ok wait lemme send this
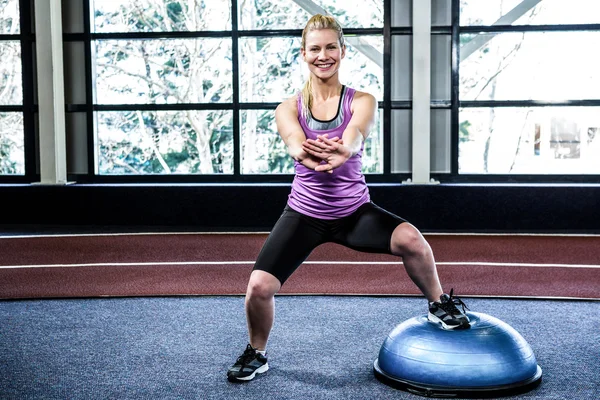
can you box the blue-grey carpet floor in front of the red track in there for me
[0,296,600,400]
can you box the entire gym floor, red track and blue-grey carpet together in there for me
[0,232,600,399]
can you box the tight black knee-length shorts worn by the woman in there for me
[254,203,406,285]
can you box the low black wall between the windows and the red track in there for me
[0,184,600,233]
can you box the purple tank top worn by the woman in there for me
[288,86,370,219]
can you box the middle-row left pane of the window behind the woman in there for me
[94,38,233,104]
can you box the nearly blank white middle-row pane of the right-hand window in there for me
[460,31,600,101]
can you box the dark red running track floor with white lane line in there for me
[0,233,600,299]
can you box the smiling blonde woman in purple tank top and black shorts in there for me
[227,15,469,381]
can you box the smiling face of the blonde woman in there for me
[302,29,346,80]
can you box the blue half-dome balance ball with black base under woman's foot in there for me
[373,312,542,398]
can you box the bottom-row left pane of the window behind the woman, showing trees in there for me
[96,110,233,175]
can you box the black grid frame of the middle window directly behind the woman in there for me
[70,0,391,184]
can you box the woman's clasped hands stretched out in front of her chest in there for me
[300,134,351,174]
